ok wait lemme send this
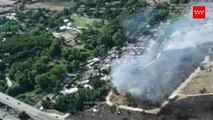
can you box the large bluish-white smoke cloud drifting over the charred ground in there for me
[111,3,213,102]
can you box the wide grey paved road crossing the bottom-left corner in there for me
[0,92,59,120]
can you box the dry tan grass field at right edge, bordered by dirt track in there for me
[181,70,213,94]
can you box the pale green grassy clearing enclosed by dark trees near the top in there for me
[71,15,100,27]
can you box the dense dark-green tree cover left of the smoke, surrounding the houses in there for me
[0,0,172,113]
